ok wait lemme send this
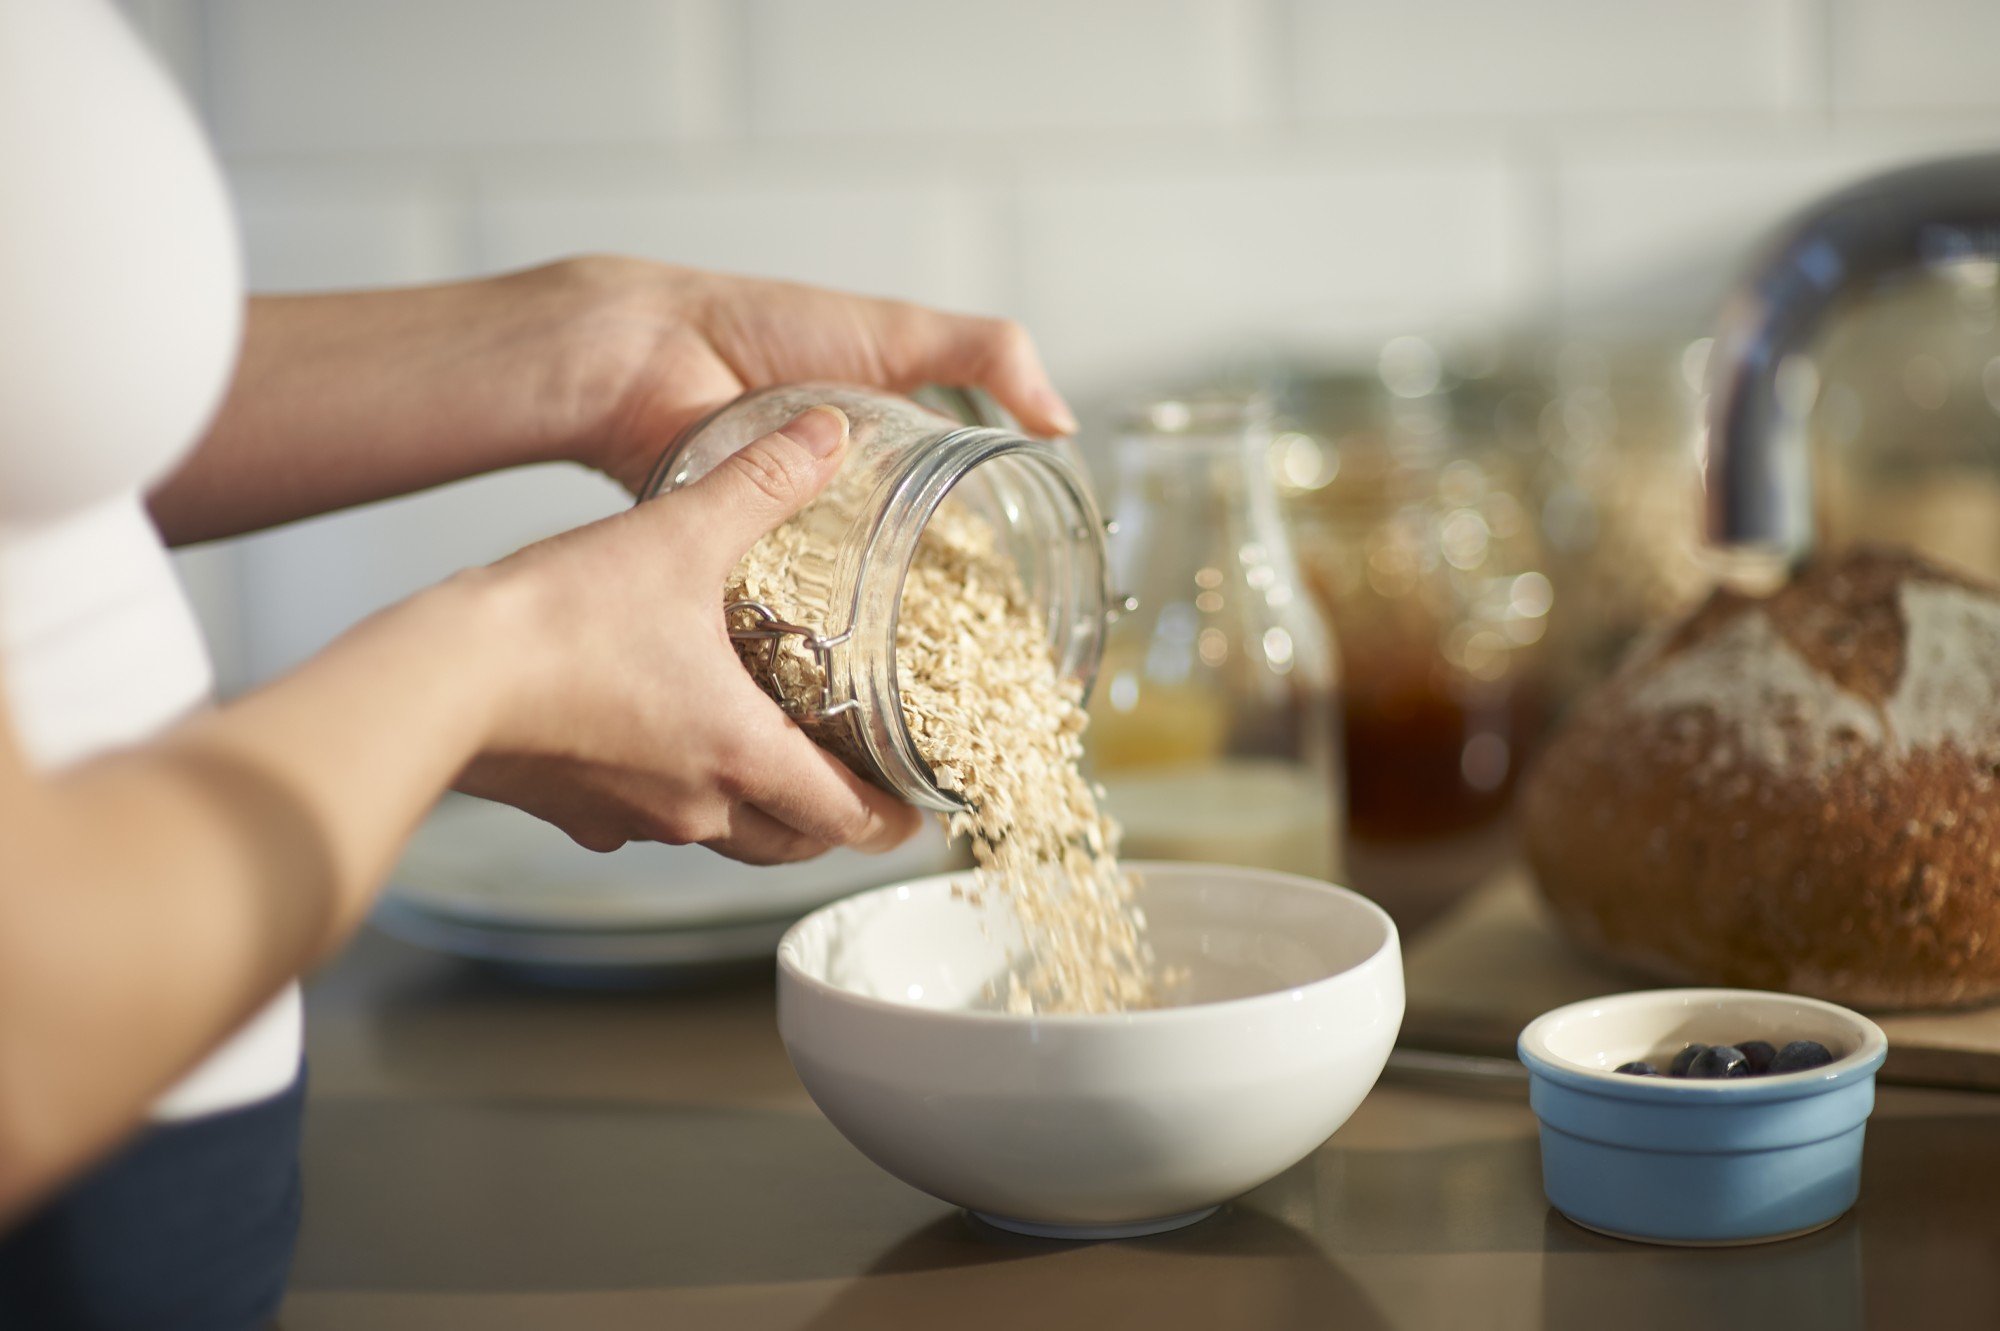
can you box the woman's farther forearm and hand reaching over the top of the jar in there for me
[152,258,1076,546]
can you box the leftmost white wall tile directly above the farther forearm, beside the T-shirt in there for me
[230,164,466,292]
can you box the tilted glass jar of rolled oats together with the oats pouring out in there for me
[644,384,1158,1011]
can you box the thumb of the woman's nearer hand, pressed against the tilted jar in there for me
[668,406,848,572]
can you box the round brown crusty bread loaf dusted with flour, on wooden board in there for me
[1522,550,2000,1009]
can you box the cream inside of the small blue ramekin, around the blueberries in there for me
[1522,989,1882,1073]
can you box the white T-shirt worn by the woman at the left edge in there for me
[0,0,300,1119]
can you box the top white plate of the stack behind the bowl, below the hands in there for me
[384,795,964,927]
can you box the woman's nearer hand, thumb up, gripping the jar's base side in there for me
[458,408,920,863]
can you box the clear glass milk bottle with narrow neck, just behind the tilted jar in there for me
[1086,398,1342,877]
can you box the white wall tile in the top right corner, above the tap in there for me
[1832,0,2000,111]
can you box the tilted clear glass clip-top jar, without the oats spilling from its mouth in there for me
[640,384,1110,813]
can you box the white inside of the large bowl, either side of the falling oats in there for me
[778,863,1394,1011]
